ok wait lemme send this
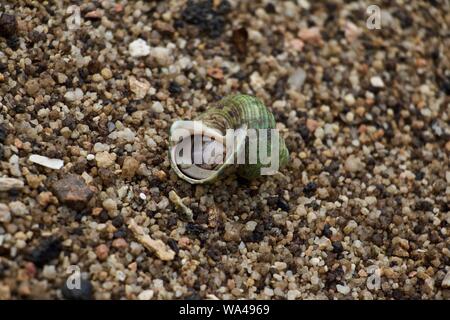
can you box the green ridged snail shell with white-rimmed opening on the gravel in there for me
[169,94,289,184]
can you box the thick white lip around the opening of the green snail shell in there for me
[169,120,247,184]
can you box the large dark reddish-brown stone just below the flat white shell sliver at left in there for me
[52,174,94,210]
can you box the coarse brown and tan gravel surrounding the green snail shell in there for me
[0,0,450,300]
